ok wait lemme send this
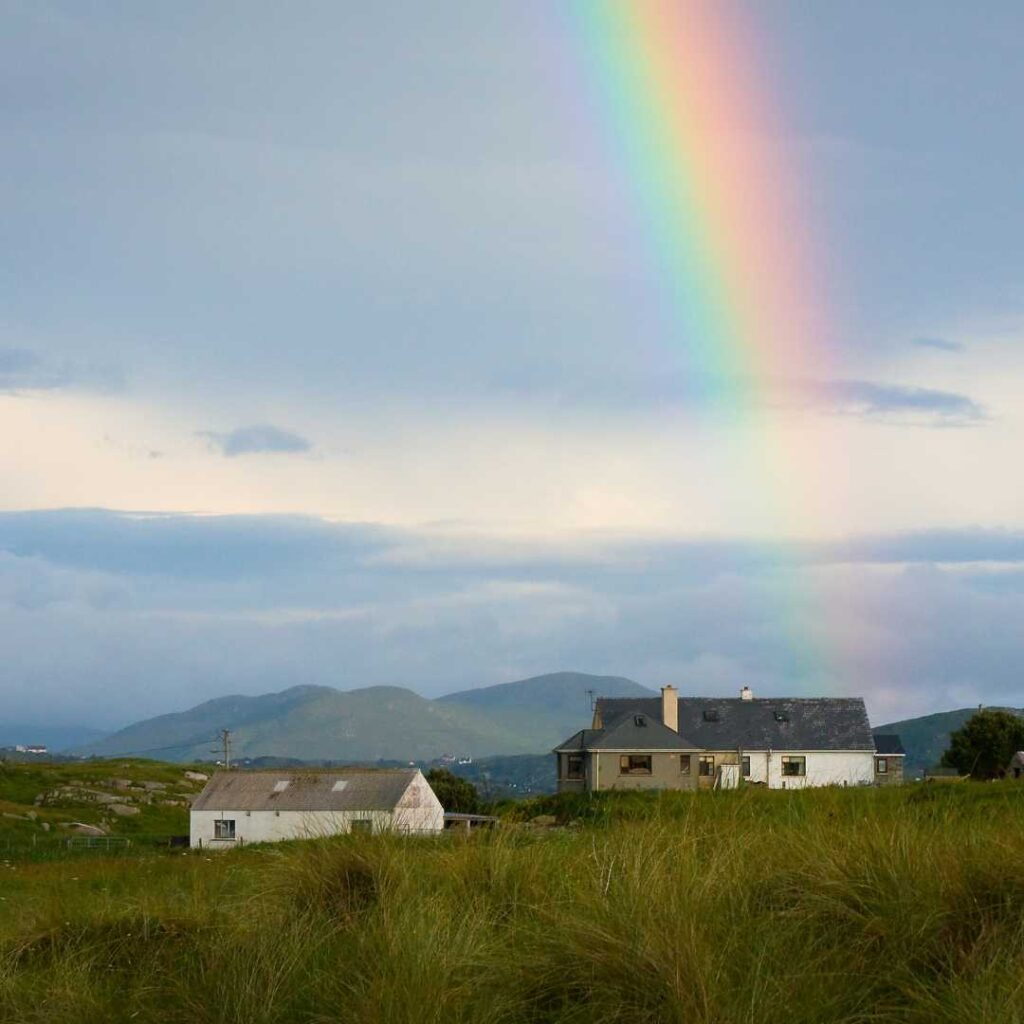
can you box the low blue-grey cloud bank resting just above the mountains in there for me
[0,510,1024,725]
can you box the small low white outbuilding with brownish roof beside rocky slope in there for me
[189,768,444,850]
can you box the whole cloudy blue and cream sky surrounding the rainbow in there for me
[0,0,1024,728]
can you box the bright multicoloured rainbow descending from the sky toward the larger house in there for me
[567,0,837,683]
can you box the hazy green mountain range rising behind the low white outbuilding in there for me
[77,672,651,761]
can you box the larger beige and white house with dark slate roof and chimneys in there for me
[554,686,903,793]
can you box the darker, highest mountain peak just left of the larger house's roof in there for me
[437,672,656,754]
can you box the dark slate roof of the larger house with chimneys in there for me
[559,697,876,751]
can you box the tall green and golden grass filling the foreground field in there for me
[0,783,1024,1024]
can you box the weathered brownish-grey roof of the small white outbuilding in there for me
[191,768,417,811]
